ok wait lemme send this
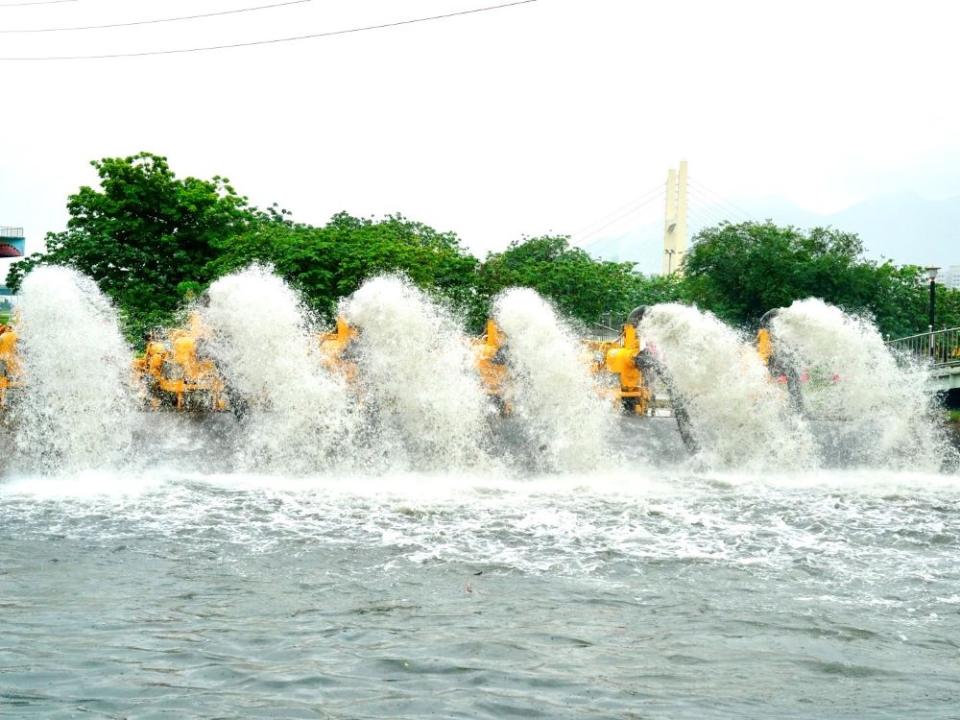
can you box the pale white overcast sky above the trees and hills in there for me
[0,0,960,279]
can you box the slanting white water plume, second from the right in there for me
[640,303,816,469]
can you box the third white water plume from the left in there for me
[341,276,493,469]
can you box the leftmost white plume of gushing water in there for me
[10,266,135,473]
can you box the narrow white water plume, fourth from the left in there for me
[494,288,616,471]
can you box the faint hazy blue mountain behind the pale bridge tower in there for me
[583,193,960,272]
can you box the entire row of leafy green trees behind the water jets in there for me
[7,153,960,338]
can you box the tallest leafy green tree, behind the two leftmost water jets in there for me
[7,153,256,336]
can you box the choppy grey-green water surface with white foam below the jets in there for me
[0,467,960,718]
